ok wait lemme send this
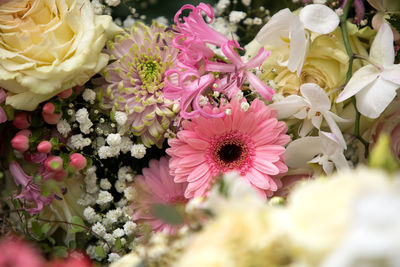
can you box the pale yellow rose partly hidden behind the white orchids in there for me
[246,23,374,100]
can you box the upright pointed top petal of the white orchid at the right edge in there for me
[369,23,394,66]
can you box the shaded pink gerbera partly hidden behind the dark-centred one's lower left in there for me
[133,157,187,233]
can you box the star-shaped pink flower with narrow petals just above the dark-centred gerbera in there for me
[204,41,274,101]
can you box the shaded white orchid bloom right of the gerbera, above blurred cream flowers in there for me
[285,131,349,174]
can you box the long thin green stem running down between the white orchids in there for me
[340,0,369,158]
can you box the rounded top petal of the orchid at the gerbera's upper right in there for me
[300,83,331,111]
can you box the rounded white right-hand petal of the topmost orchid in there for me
[299,4,339,34]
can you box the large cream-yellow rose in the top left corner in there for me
[0,0,119,110]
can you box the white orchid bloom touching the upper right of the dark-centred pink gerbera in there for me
[269,83,348,147]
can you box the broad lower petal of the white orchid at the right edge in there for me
[356,77,399,119]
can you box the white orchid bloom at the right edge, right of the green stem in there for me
[336,23,400,119]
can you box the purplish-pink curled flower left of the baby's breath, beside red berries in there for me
[9,162,53,214]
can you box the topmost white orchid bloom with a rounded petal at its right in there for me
[256,4,339,76]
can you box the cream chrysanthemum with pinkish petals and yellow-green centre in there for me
[100,22,178,147]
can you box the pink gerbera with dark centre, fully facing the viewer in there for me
[167,98,290,198]
